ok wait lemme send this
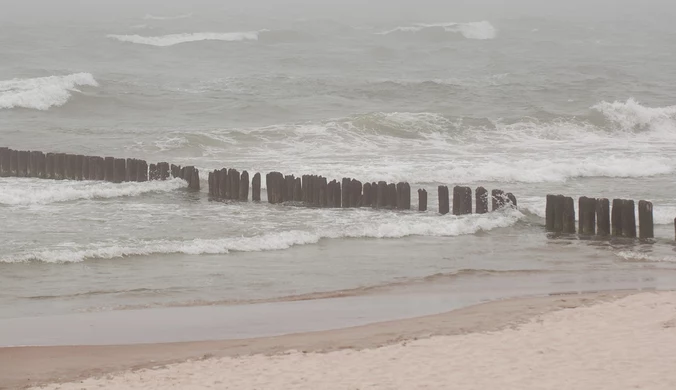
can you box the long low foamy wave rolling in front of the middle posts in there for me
[0,209,523,263]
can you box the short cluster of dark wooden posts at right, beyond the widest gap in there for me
[545,195,654,238]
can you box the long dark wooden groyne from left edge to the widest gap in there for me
[0,147,516,216]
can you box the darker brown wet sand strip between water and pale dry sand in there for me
[0,290,654,389]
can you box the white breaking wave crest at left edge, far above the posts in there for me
[0,73,99,110]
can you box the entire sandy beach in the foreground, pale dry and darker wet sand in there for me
[0,292,676,390]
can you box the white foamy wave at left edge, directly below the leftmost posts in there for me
[0,179,186,206]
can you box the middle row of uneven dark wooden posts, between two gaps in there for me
[209,168,516,215]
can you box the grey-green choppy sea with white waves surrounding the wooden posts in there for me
[0,1,676,345]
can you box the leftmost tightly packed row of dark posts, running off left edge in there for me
[0,147,200,190]
